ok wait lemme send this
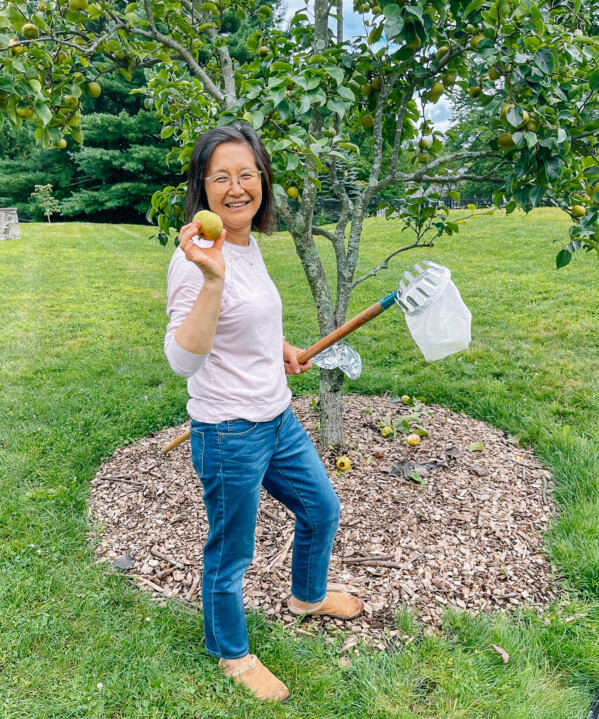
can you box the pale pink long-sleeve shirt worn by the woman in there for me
[164,237,291,423]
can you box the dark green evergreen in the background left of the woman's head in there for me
[0,70,180,222]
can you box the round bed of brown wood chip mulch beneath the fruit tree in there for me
[89,395,560,648]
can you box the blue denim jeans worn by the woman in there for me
[191,408,339,659]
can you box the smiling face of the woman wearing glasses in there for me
[204,142,262,232]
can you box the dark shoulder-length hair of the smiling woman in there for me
[185,122,275,234]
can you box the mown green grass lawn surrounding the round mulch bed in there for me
[0,210,599,719]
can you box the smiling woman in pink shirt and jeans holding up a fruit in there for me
[165,124,363,701]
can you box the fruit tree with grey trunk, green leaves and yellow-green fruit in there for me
[0,0,599,445]
